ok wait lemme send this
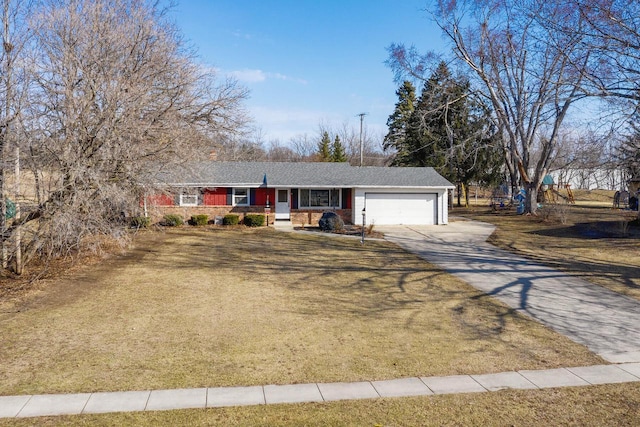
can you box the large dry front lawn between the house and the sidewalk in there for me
[0,228,601,395]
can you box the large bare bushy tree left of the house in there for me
[4,0,246,270]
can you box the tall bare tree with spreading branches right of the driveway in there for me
[390,0,589,213]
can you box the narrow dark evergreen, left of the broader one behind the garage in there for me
[382,80,416,165]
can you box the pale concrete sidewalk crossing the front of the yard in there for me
[0,363,640,418]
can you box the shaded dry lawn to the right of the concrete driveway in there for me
[453,205,640,299]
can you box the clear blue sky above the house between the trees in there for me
[172,0,443,144]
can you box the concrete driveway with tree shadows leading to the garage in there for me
[376,221,640,363]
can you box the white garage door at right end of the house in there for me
[365,193,437,225]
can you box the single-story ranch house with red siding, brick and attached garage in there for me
[144,161,454,225]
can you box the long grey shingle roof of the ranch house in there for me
[158,161,453,188]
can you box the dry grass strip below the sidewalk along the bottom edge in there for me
[0,383,640,427]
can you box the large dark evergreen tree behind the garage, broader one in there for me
[389,63,503,206]
